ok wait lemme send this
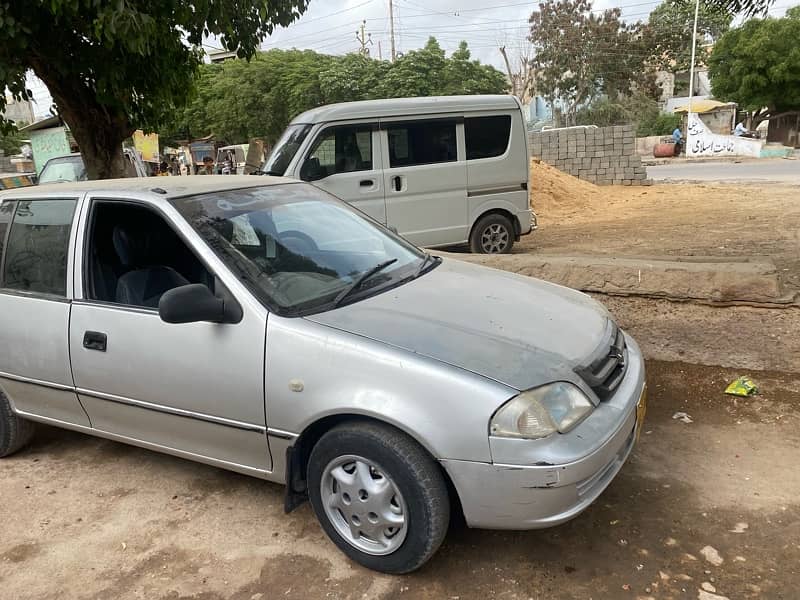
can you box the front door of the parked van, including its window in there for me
[299,123,386,224]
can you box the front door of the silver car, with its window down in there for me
[69,197,272,475]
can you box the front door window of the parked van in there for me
[300,125,372,181]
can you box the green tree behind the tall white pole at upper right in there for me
[643,0,733,72]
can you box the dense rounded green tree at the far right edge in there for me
[709,7,800,127]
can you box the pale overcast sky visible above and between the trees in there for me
[29,0,798,117]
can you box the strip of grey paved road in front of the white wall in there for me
[647,159,800,184]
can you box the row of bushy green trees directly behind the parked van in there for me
[168,38,507,143]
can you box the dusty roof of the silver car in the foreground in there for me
[0,175,298,200]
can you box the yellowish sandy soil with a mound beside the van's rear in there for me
[515,163,800,290]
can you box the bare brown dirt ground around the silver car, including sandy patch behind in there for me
[0,169,800,600]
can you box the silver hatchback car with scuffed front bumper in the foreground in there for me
[0,176,645,573]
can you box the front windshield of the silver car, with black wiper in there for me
[172,183,437,316]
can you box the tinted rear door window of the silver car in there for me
[3,200,78,297]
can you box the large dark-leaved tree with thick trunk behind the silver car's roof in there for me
[0,0,308,179]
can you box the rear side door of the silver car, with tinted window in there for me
[0,194,90,427]
